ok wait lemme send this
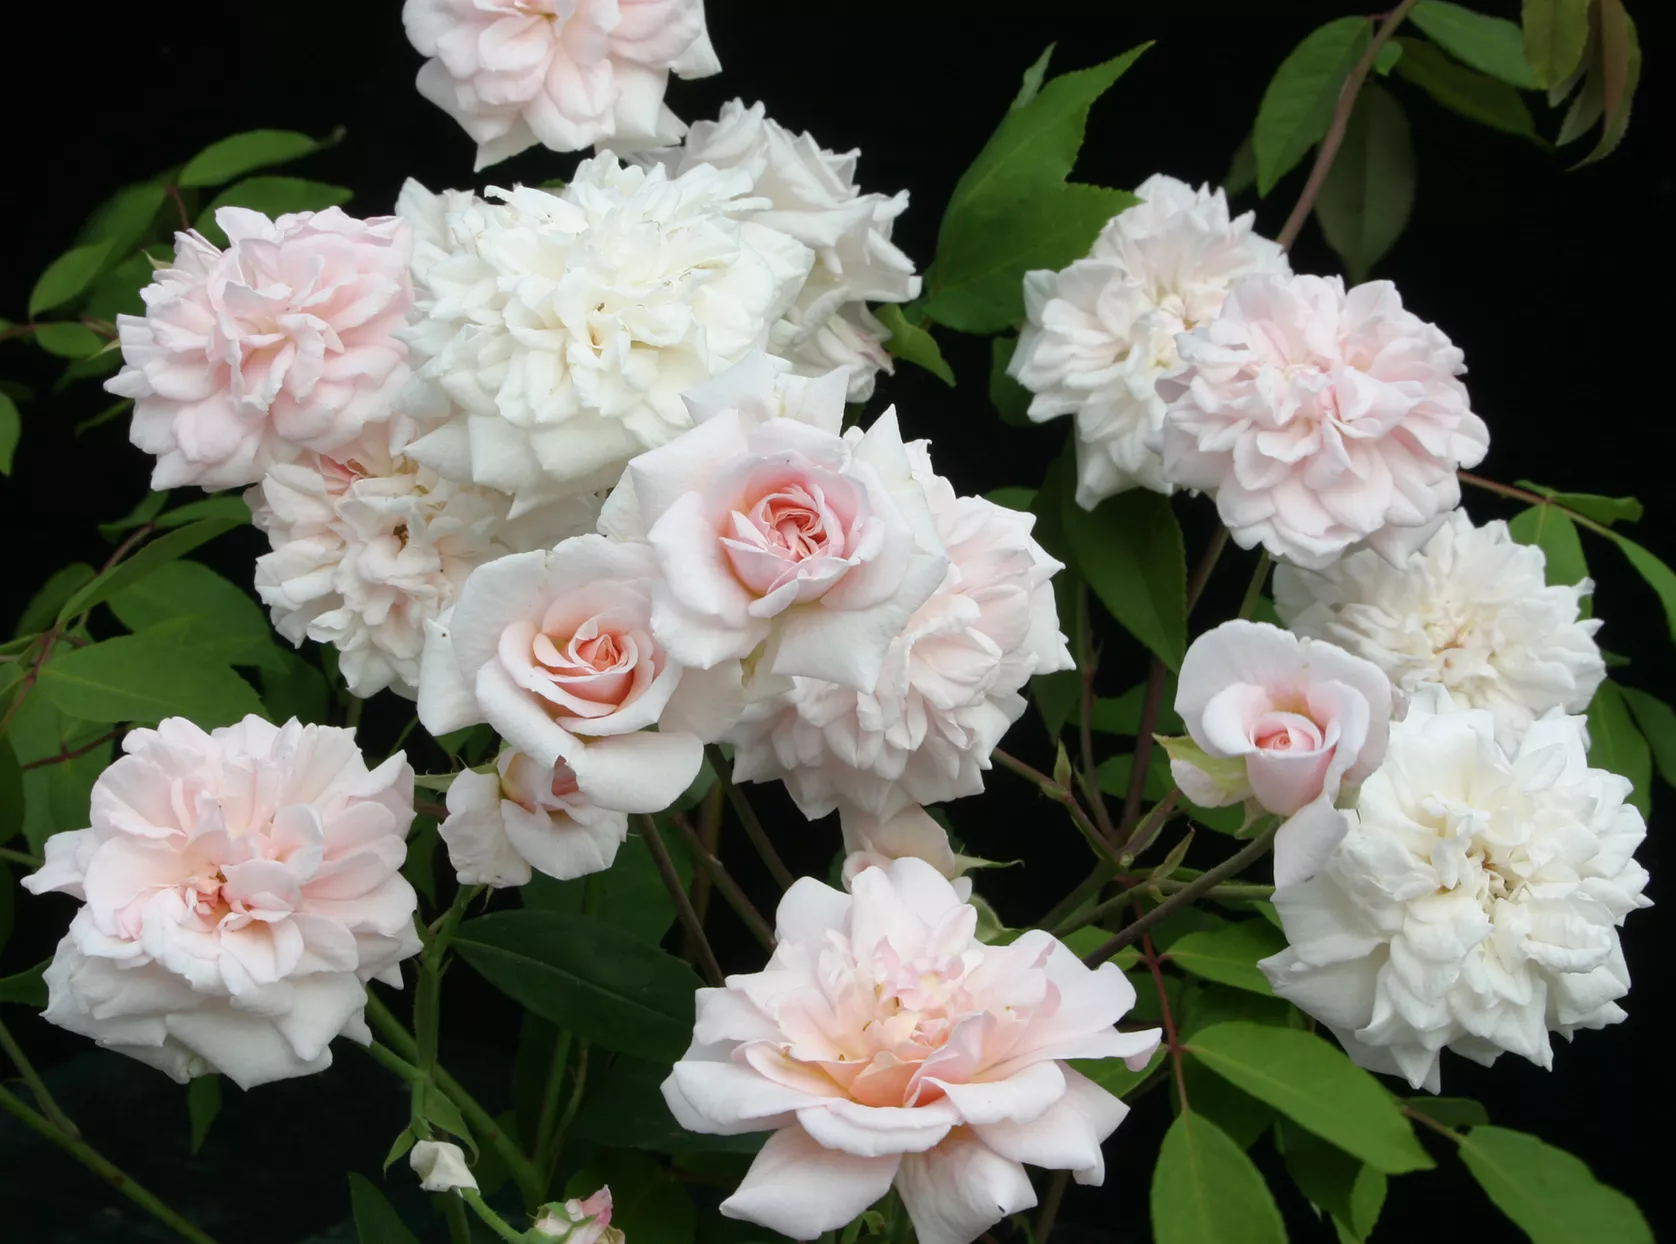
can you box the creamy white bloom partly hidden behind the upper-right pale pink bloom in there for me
[1007,173,1291,510]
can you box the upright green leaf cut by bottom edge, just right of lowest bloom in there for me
[1151,1112,1285,1244]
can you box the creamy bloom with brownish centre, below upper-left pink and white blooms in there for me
[245,416,597,699]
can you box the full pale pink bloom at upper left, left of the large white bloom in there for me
[106,208,412,490]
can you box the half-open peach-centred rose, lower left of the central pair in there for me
[419,535,727,818]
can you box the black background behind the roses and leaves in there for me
[0,0,1676,1244]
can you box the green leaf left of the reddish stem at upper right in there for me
[1252,17,1373,198]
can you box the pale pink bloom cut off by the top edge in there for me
[402,0,721,169]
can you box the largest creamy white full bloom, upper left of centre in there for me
[397,154,815,516]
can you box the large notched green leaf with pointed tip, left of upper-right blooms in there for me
[923,45,1146,332]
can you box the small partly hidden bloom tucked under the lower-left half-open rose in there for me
[439,751,629,887]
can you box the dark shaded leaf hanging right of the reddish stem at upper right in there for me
[1316,82,1414,282]
